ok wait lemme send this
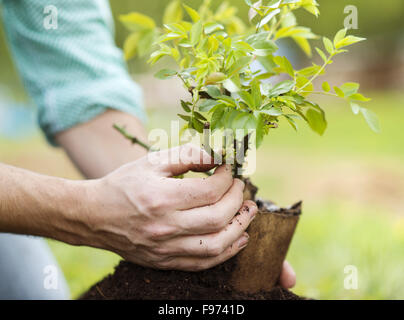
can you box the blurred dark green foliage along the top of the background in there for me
[0,0,404,94]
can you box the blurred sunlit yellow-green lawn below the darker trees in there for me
[0,93,404,299]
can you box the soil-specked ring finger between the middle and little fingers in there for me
[156,201,258,257]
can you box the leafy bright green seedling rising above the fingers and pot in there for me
[120,0,379,176]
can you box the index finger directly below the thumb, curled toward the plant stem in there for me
[161,165,233,210]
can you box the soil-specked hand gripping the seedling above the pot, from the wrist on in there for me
[76,144,257,271]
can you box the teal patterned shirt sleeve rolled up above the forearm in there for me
[2,0,145,144]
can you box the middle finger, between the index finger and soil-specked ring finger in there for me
[170,179,244,235]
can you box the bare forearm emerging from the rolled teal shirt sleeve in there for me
[56,110,147,178]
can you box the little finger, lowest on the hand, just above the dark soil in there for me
[156,235,248,272]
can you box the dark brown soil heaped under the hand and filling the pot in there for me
[80,200,303,300]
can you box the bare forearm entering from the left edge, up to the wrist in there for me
[0,164,91,244]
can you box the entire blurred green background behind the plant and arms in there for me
[0,0,404,299]
